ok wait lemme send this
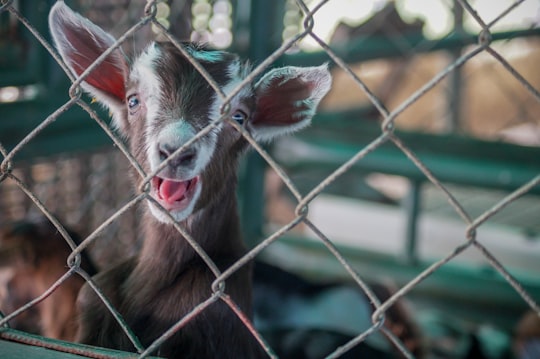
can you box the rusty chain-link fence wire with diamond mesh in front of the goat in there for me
[0,0,540,358]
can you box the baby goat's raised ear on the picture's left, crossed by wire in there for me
[49,1,128,113]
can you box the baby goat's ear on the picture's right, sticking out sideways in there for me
[249,64,332,141]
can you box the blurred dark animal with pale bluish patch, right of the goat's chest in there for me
[254,261,425,359]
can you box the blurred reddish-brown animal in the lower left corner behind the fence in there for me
[0,219,96,341]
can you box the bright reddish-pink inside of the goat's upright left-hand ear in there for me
[66,29,126,101]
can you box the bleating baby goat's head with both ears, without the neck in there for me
[49,2,331,222]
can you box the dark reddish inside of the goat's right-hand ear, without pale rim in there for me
[252,76,314,126]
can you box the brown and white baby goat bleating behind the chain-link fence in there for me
[49,2,331,358]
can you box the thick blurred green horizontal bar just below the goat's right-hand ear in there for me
[276,114,540,194]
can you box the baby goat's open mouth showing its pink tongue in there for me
[152,176,199,211]
